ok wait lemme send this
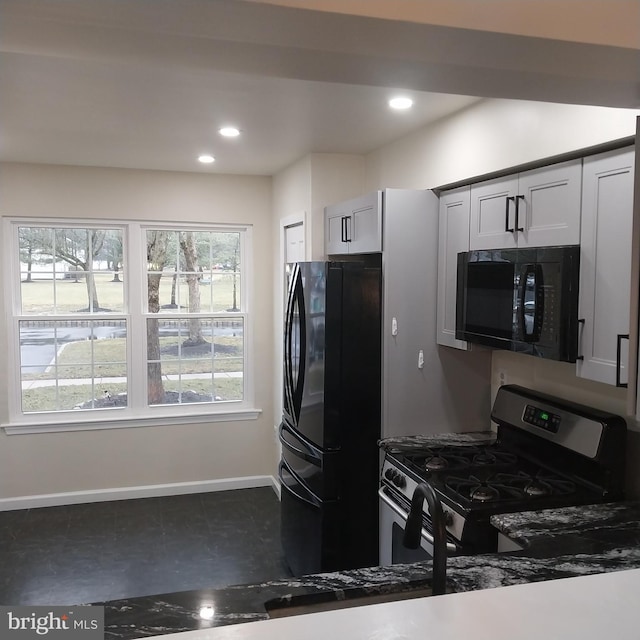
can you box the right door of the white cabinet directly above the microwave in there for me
[515,159,582,247]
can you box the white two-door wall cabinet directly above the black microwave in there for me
[469,160,582,250]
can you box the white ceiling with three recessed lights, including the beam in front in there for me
[0,0,640,175]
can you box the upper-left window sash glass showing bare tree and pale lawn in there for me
[18,227,124,315]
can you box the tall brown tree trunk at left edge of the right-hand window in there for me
[147,231,169,404]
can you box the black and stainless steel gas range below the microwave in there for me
[378,385,626,565]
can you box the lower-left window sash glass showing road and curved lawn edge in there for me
[20,320,127,413]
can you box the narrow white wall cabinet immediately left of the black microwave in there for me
[436,186,471,349]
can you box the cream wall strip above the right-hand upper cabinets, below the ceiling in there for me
[366,100,640,189]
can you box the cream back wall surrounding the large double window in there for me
[0,164,275,499]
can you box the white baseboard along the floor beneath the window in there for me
[0,476,280,511]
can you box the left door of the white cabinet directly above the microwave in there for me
[469,176,518,250]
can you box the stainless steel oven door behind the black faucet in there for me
[378,486,459,567]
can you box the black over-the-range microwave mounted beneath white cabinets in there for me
[456,245,580,362]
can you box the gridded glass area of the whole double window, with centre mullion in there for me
[12,223,247,421]
